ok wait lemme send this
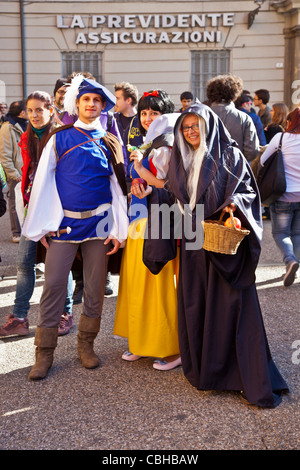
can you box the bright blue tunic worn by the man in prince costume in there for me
[53,127,112,242]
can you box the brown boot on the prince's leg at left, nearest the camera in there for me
[29,326,58,380]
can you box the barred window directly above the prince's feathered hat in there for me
[62,51,102,83]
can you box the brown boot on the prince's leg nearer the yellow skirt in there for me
[77,315,100,369]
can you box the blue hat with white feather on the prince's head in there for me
[64,74,116,115]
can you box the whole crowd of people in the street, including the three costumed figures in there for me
[0,72,294,408]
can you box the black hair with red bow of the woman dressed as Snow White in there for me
[137,90,175,135]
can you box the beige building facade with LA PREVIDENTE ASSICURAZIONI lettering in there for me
[0,0,300,108]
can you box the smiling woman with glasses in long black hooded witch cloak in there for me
[132,103,288,408]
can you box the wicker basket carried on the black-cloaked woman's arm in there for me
[202,209,250,255]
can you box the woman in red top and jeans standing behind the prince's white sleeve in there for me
[0,91,73,336]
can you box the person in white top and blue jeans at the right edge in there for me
[260,108,300,287]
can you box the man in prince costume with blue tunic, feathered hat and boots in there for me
[23,74,128,380]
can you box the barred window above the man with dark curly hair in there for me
[192,50,230,101]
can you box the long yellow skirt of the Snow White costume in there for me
[114,219,179,358]
